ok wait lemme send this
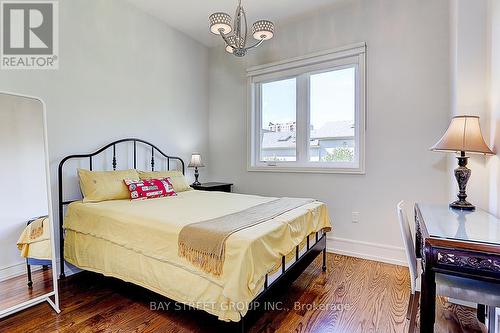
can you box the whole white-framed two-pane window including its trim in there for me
[248,43,365,173]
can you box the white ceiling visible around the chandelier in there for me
[128,0,340,46]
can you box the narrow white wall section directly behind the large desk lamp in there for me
[452,0,490,209]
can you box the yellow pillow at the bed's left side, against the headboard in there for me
[78,169,139,202]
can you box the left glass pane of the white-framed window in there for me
[260,78,297,161]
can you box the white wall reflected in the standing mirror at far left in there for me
[0,94,48,280]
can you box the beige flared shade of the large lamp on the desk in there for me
[431,116,493,155]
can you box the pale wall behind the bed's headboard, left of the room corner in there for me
[0,0,208,272]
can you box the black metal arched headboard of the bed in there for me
[57,138,185,278]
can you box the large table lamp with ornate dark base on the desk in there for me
[431,116,493,210]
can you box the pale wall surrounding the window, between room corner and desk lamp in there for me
[207,0,451,261]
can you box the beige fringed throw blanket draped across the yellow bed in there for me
[179,198,315,276]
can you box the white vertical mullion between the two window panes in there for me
[296,75,308,163]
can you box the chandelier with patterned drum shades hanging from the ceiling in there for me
[208,0,274,57]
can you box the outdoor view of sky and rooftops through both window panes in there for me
[260,67,356,162]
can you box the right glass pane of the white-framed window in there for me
[309,67,356,162]
